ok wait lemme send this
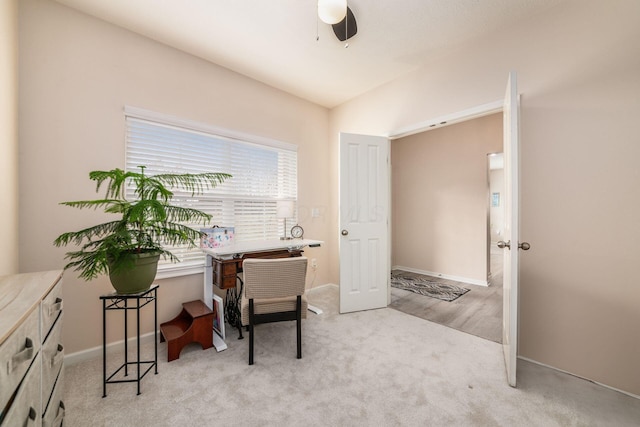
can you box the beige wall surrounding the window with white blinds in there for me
[19,0,329,354]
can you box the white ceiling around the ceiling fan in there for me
[56,0,564,108]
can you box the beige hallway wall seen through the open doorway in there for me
[391,113,502,284]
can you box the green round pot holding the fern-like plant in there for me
[109,252,160,294]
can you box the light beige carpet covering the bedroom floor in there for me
[65,286,640,427]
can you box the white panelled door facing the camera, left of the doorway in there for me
[339,133,390,313]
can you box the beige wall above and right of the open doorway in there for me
[330,0,640,395]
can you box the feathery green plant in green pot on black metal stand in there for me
[54,166,231,293]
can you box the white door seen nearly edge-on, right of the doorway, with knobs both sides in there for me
[498,71,519,387]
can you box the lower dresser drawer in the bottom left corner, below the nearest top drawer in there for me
[2,354,42,426]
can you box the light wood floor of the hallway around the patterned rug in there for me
[389,250,502,343]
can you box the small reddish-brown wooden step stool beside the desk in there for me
[160,300,213,362]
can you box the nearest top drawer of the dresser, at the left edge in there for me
[0,309,40,412]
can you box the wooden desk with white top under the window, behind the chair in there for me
[201,239,322,346]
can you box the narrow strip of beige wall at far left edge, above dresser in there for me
[0,0,18,276]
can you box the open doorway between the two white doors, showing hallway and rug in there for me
[389,112,503,343]
